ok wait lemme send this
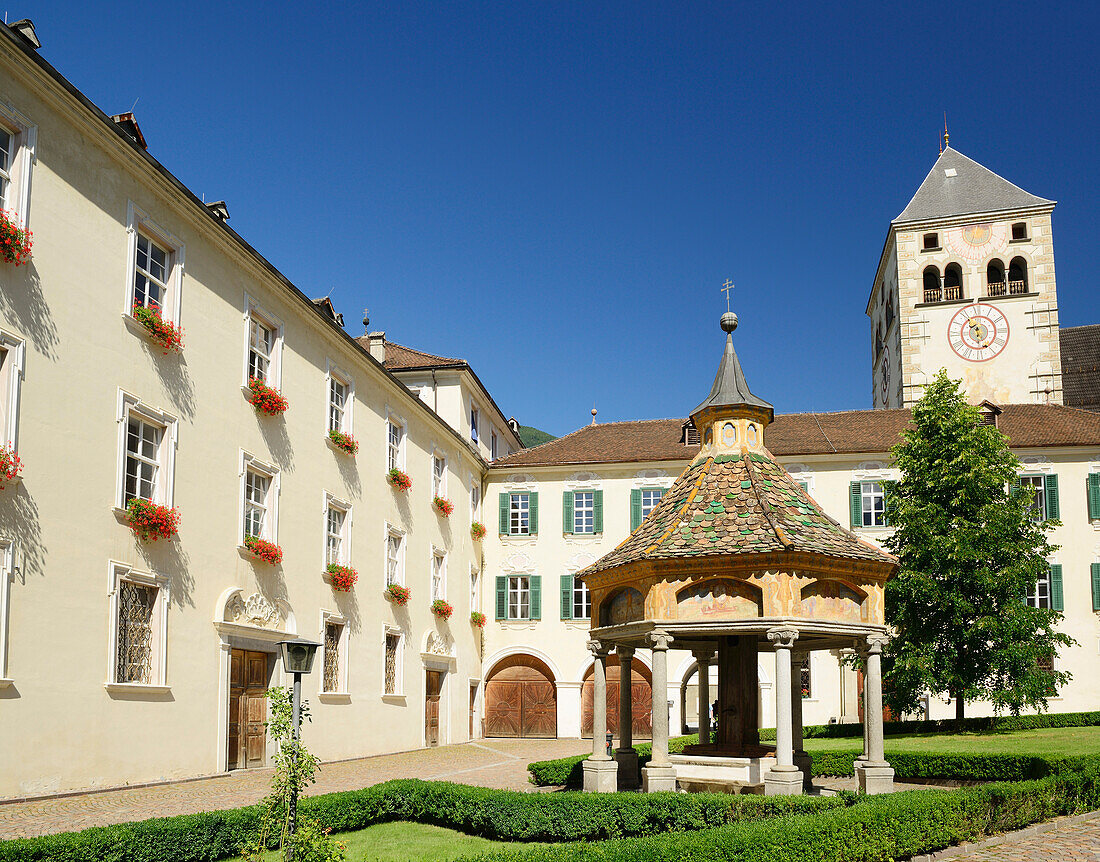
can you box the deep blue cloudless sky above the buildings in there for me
[21,0,1100,434]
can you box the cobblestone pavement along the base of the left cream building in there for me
[0,739,592,839]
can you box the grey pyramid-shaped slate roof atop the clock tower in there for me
[893,147,1054,224]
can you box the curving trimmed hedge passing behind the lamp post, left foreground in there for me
[0,778,844,862]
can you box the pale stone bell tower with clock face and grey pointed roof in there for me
[867,139,1062,408]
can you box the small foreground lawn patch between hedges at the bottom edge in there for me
[264,822,545,862]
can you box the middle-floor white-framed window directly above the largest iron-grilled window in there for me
[116,391,176,509]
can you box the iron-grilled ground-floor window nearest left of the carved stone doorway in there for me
[108,562,168,689]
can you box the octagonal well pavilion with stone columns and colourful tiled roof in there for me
[582,311,898,794]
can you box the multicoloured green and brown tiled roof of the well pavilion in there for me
[585,453,895,574]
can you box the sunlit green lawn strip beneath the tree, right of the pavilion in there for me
[804,727,1100,759]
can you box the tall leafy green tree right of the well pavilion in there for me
[884,369,1074,718]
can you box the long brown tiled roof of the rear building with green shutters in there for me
[493,405,1100,468]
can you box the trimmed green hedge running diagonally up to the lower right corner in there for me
[468,758,1100,862]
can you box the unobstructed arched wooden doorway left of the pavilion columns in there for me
[485,654,558,739]
